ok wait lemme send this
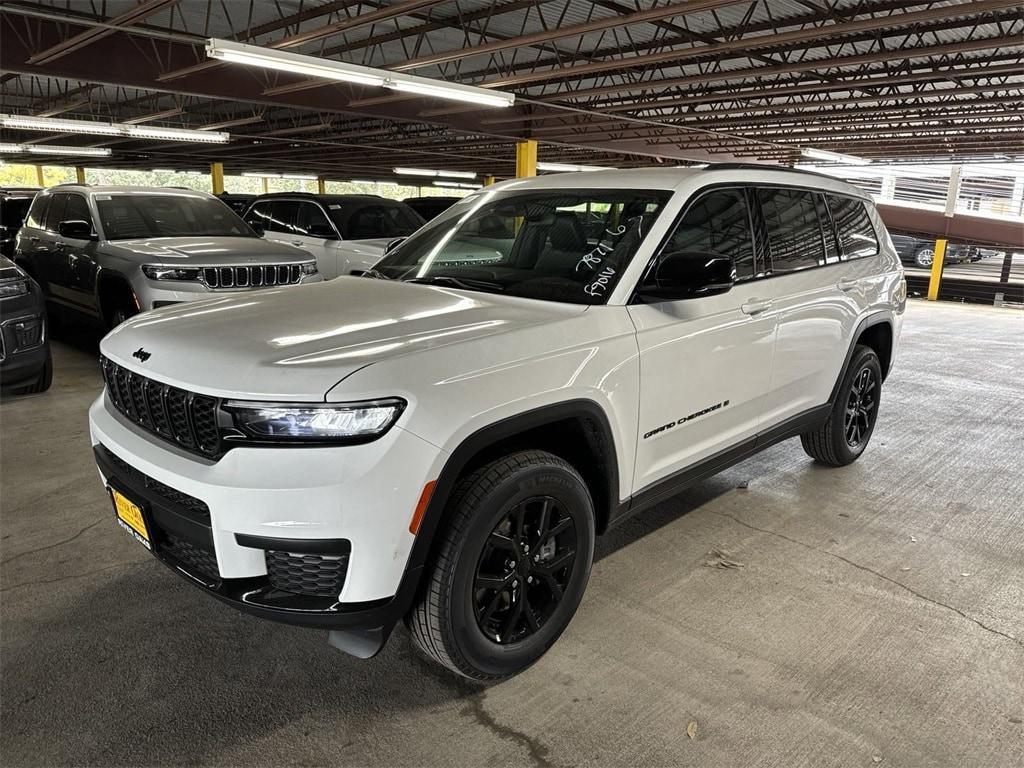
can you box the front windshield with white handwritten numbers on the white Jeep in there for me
[370,189,670,304]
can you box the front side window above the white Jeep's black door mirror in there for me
[664,188,764,282]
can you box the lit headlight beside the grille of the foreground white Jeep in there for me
[223,397,406,442]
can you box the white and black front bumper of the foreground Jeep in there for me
[89,393,442,631]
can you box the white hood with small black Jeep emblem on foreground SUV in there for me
[100,278,586,401]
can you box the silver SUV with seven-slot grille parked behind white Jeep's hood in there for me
[14,184,323,328]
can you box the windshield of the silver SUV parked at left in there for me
[96,194,256,240]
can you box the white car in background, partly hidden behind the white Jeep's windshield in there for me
[245,193,423,280]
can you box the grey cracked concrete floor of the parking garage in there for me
[0,302,1024,767]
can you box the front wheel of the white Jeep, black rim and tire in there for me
[406,451,595,680]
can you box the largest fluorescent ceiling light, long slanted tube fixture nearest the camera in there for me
[206,39,515,106]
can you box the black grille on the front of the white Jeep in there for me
[102,357,221,458]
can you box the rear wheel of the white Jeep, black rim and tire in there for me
[800,344,882,467]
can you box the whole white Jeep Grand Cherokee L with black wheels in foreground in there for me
[90,165,905,679]
